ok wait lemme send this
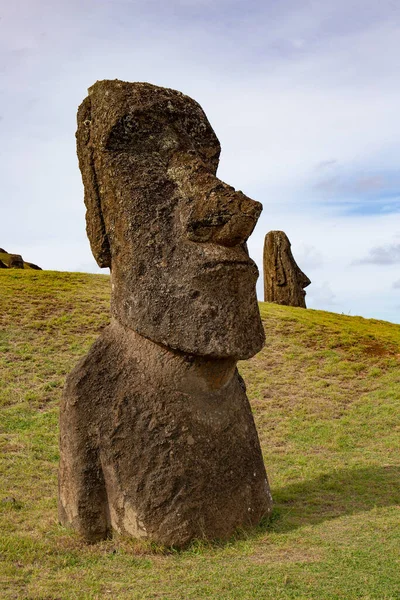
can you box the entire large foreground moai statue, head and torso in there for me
[59,80,272,546]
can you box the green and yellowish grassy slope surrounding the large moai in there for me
[0,270,400,600]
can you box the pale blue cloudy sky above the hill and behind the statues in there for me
[0,0,400,323]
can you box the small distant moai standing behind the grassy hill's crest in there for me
[264,231,311,308]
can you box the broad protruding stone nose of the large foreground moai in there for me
[187,178,262,246]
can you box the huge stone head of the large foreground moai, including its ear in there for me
[77,80,264,359]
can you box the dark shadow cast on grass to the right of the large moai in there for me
[263,466,400,533]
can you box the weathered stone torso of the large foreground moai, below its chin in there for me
[60,320,270,546]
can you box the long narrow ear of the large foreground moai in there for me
[76,97,111,268]
